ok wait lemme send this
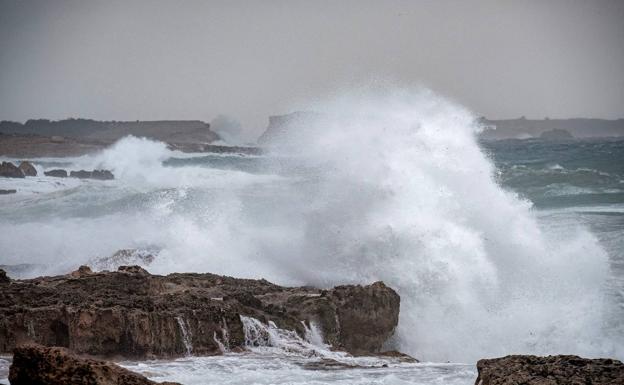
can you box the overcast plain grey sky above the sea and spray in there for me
[0,0,624,136]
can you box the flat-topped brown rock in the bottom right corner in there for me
[475,355,624,385]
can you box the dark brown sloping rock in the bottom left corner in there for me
[9,344,179,385]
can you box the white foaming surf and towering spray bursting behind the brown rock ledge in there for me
[0,92,624,362]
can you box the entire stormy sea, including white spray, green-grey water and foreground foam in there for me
[0,93,624,384]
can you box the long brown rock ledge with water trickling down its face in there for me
[0,266,399,358]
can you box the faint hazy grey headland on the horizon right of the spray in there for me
[479,118,624,139]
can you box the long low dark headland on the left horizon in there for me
[0,119,219,143]
